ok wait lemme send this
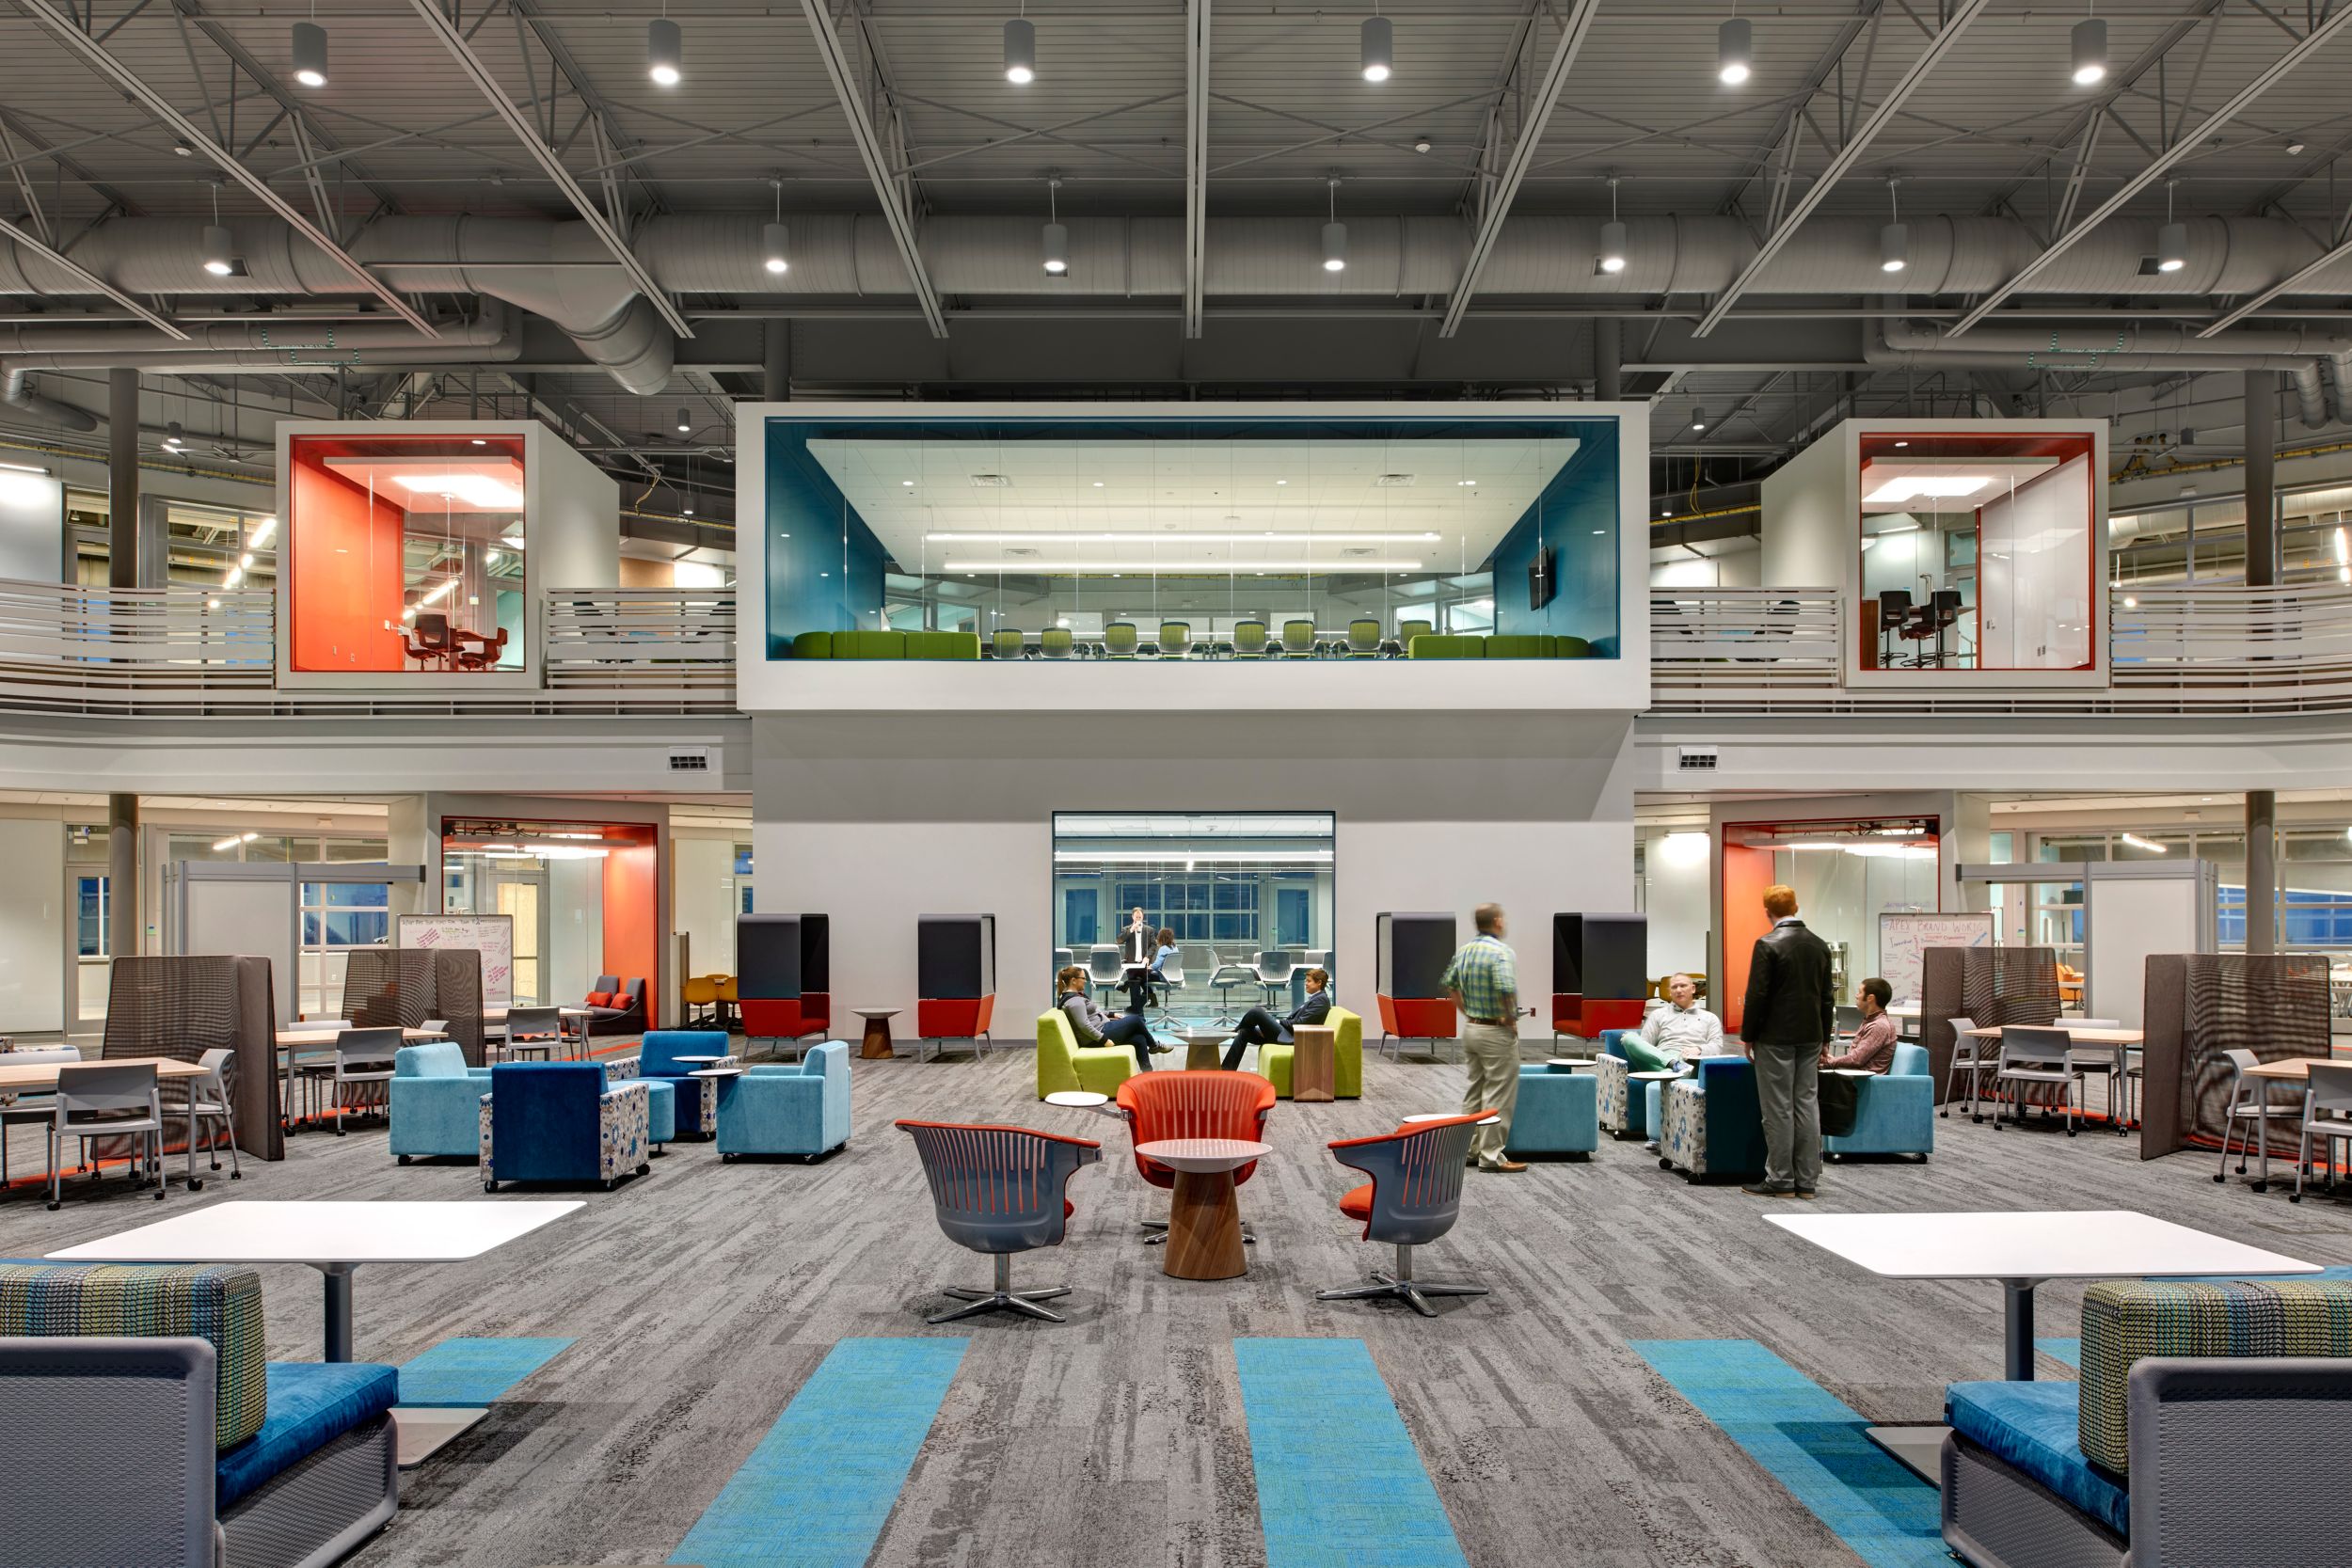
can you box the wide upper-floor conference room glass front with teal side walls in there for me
[767,419,1618,660]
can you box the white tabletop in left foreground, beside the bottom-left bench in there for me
[50,1199,586,1265]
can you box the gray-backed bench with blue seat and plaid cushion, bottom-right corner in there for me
[1943,1281,2352,1568]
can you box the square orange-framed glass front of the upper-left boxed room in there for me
[287,435,525,673]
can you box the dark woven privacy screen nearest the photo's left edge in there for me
[99,955,285,1159]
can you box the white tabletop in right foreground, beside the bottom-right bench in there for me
[1764,1209,2319,1279]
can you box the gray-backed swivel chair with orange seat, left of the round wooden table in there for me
[897,1114,1101,1323]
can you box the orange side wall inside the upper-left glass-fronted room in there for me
[287,458,407,670]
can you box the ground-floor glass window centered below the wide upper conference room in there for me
[1047,811,1336,1027]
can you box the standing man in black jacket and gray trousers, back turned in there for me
[1740,884,1837,1199]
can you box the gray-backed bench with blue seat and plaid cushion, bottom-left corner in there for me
[0,1262,400,1568]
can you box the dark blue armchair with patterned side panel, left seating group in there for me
[483,1063,654,1192]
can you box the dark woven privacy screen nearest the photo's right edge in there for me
[2140,952,2328,1159]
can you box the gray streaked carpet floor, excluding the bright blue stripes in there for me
[0,1049,2352,1568]
